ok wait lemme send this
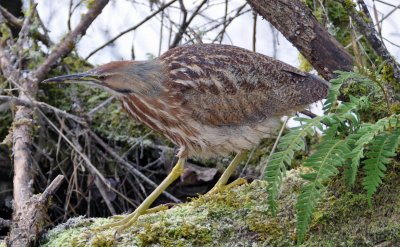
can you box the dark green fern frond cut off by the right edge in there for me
[362,129,400,206]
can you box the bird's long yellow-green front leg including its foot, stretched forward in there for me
[100,158,185,231]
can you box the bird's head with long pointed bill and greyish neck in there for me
[43,60,165,96]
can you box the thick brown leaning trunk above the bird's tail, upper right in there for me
[247,0,353,80]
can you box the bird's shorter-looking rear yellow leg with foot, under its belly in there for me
[208,152,246,194]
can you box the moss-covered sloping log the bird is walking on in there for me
[34,170,400,247]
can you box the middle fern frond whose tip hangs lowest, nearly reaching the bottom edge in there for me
[296,139,350,243]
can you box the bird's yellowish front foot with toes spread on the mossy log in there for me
[93,205,169,233]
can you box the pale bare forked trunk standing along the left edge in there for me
[0,0,109,246]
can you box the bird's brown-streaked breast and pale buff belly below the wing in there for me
[121,93,279,156]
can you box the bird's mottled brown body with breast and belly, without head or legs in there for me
[123,44,328,156]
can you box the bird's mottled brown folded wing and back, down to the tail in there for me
[160,44,328,126]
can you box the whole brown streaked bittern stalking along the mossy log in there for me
[44,43,329,230]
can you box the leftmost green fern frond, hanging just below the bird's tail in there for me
[264,117,322,214]
